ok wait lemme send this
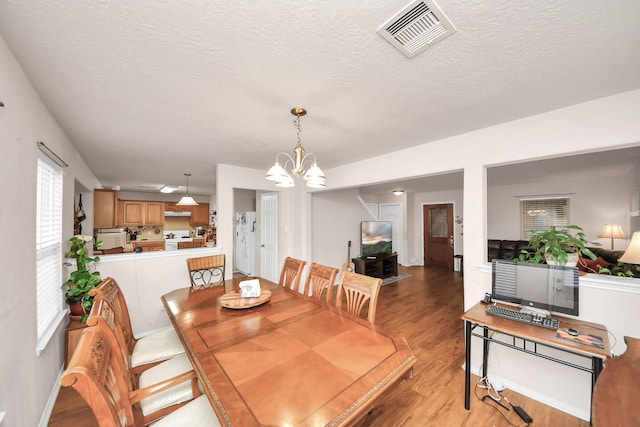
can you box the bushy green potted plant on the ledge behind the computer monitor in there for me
[517,224,597,266]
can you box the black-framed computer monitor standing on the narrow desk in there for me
[491,259,580,316]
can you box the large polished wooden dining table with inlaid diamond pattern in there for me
[162,278,416,427]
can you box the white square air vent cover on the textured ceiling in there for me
[378,0,456,58]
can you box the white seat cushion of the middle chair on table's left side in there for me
[138,354,193,415]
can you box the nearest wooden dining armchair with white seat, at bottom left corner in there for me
[60,327,220,427]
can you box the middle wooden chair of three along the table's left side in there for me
[85,298,202,418]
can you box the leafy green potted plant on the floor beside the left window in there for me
[64,234,102,322]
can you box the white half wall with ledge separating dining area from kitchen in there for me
[96,247,225,337]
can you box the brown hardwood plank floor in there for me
[49,267,589,427]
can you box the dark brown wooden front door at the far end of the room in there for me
[422,203,453,270]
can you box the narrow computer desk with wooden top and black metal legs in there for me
[462,303,611,422]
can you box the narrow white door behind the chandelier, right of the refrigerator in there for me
[260,193,280,283]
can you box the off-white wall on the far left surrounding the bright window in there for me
[0,38,100,426]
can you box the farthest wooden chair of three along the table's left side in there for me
[89,277,184,372]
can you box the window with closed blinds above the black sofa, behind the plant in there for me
[520,197,571,240]
